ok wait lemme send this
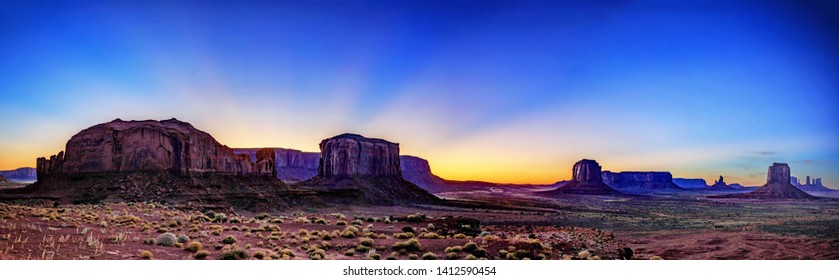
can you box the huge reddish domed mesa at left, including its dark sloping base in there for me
[3,119,311,208]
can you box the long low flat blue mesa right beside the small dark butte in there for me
[602,171,684,192]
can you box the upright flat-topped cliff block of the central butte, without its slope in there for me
[318,133,402,178]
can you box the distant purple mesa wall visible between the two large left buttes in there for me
[233,148,320,182]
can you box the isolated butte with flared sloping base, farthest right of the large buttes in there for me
[728,163,815,199]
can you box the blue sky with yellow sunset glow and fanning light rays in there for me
[0,0,839,188]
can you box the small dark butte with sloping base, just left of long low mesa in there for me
[544,159,618,195]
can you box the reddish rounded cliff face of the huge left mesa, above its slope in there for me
[37,119,254,179]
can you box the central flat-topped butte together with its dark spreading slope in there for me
[298,134,438,205]
